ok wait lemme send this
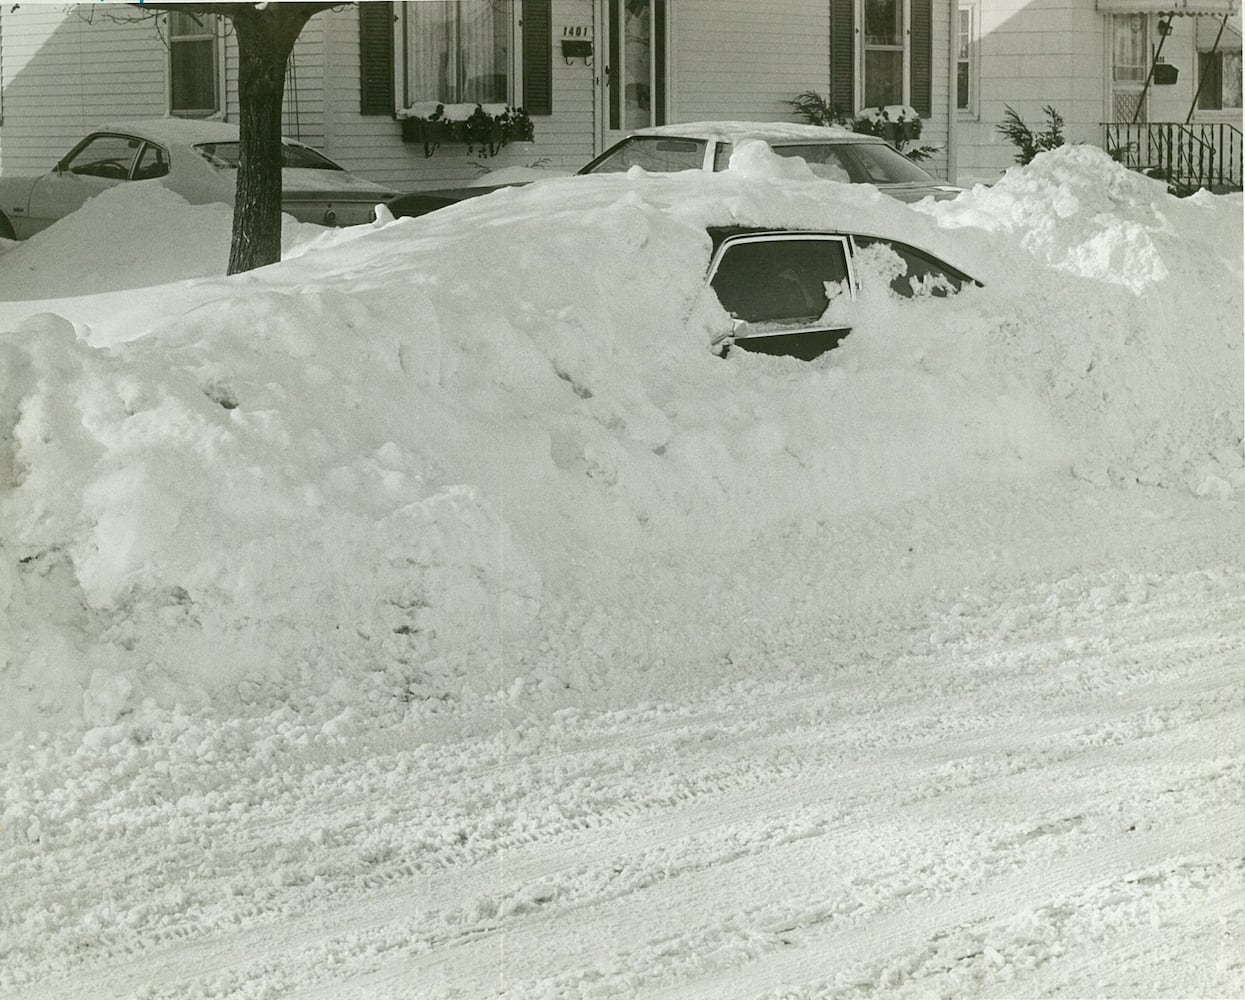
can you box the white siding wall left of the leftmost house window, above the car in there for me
[0,4,168,174]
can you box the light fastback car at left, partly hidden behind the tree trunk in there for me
[0,118,393,239]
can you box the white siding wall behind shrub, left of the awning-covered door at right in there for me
[956,0,1107,183]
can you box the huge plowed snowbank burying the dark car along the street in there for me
[0,142,1243,731]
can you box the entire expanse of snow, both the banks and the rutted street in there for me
[0,147,1245,1000]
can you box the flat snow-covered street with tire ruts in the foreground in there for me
[6,478,1245,998]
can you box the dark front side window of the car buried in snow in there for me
[710,237,849,326]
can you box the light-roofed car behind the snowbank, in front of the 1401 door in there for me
[387,122,962,217]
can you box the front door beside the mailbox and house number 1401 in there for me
[596,0,666,152]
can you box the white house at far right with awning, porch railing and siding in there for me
[951,0,1241,186]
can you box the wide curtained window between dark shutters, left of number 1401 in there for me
[401,0,519,107]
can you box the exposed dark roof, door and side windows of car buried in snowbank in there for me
[706,227,981,360]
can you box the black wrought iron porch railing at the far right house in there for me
[1103,122,1245,194]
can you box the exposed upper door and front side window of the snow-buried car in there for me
[708,232,855,361]
